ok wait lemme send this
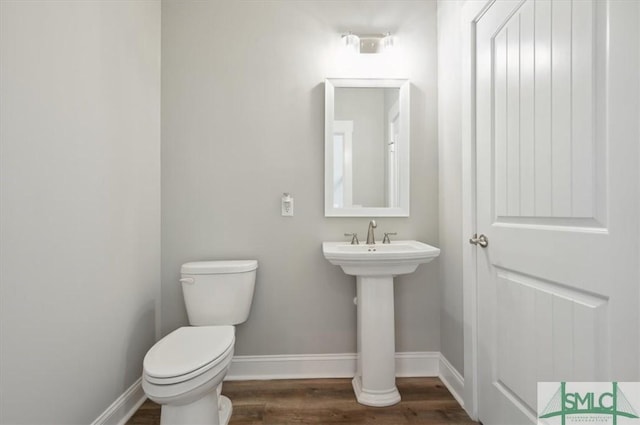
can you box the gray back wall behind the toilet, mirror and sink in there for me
[162,1,440,355]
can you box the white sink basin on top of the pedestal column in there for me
[322,241,440,276]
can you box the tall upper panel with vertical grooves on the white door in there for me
[488,0,604,225]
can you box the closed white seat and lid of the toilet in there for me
[143,326,235,385]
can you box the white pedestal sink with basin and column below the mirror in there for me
[322,241,440,407]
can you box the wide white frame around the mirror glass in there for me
[324,78,411,217]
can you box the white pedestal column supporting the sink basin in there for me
[353,276,400,407]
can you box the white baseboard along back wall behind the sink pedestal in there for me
[226,352,440,381]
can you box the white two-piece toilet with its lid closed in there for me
[142,260,258,425]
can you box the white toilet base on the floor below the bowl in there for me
[160,390,233,425]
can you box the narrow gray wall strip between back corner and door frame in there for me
[438,0,464,374]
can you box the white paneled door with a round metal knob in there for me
[475,0,640,425]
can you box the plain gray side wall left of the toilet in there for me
[0,0,160,425]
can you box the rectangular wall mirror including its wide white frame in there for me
[324,78,409,217]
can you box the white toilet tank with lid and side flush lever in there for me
[180,260,258,326]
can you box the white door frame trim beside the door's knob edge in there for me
[461,0,495,420]
